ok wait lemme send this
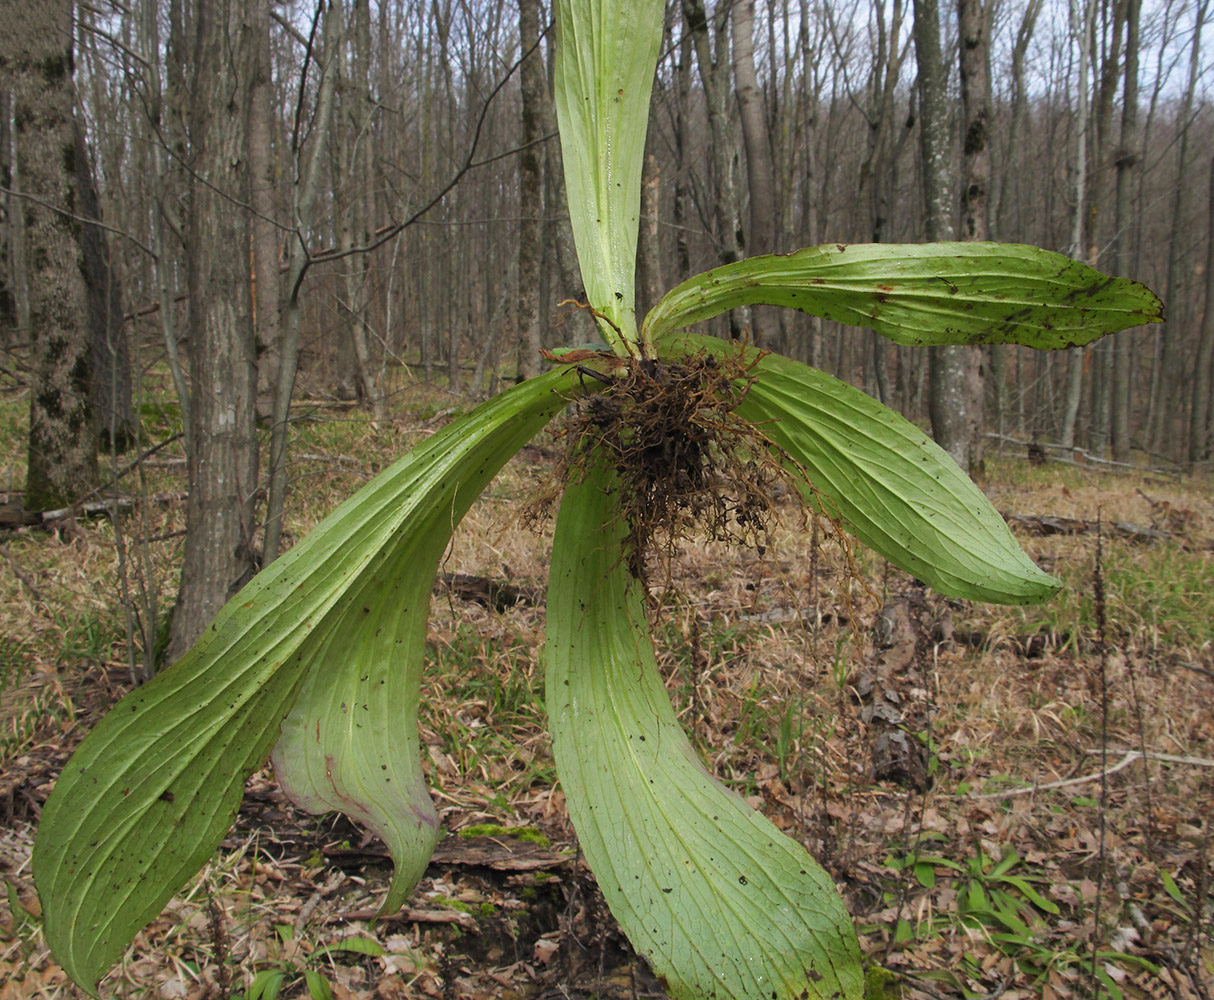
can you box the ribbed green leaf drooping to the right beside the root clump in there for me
[663,334,1060,604]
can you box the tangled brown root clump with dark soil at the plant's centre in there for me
[541,354,800,580]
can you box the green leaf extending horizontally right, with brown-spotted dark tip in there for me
[643,243,1163,348]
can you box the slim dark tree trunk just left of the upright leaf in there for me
[516,0,545,379]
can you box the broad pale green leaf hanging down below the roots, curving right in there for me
[546,456,863,1000]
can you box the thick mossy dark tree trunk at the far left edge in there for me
[0,0,98,510]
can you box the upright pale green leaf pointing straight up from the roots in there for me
[554,0,665,354]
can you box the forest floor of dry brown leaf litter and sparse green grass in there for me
[0,373,1214,1000]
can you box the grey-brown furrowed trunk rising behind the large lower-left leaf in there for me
[166,0,257,661]
